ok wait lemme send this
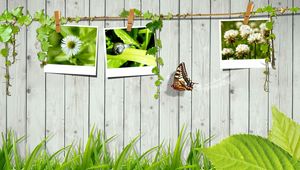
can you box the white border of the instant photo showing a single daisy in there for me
[44,25,99,76]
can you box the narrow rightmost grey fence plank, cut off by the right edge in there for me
[293,0,300,123]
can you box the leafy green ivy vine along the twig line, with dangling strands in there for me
[0,6,300,99]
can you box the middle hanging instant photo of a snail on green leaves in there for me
[105,27,156,77]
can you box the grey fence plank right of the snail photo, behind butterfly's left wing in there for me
[160,0,179,146]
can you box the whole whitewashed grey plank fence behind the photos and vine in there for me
[0,0,300,153]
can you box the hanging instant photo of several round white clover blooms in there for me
[220,18,271,69]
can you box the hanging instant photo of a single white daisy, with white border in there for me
[44,26,98,75]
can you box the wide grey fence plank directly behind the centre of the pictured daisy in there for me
[65,0,90,147]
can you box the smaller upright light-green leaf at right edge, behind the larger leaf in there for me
[269,107,300,160]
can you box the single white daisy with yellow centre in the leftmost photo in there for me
[61,35,82,57]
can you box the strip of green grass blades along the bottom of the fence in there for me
[0,128,213,170]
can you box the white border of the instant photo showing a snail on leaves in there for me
[103,26,154,78]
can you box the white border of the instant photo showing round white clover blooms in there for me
[219,18,270,70]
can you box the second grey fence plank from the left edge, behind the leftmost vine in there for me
[7,0,27,155]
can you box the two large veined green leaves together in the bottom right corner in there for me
[201,107,300,170]
